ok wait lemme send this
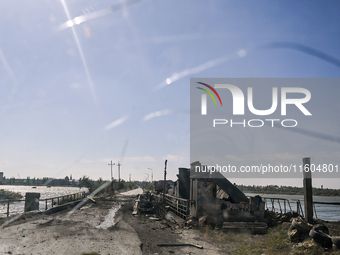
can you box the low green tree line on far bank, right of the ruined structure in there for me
[237,185,340,196]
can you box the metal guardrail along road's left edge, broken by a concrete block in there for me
[0,191,86,217]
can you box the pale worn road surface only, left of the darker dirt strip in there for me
[0,189,142,254]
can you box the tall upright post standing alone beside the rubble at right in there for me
[303,158,313,223]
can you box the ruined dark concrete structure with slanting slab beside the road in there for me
[175,161,265,225]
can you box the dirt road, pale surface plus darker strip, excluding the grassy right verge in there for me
[0,189,225,255]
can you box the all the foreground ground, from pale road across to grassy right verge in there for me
[0,190,340,255]
